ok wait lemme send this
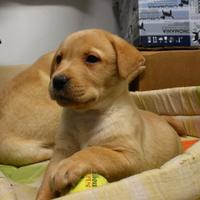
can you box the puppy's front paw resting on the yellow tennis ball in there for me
[50,158,90,195]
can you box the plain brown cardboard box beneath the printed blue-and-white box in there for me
[130,50,200,91]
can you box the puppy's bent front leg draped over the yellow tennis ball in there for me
[50,146,139,193]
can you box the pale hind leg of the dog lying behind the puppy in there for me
[0,137,53,166]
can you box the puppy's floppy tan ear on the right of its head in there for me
[109,34,145,80]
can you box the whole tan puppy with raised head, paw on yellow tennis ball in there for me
[37,29,182,200]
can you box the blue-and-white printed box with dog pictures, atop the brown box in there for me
[115,0,200,48]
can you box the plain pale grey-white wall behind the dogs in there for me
[0,0,118,65]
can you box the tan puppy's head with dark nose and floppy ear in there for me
[49,29,144,109]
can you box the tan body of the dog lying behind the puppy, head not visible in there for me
[0,52,60,166]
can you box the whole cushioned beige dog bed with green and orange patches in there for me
[0,86,200,200]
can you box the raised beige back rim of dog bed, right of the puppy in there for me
[132,86,200,137]
